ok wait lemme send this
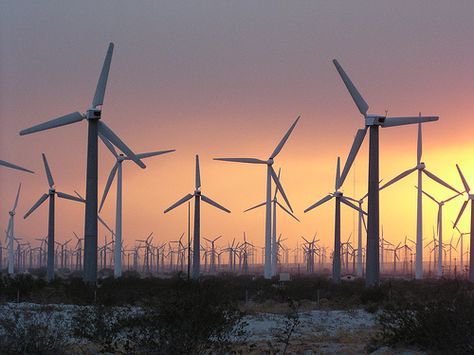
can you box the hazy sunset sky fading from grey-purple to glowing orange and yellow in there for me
[0,0,474,254]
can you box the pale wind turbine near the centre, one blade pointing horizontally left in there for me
[214,116,300,279]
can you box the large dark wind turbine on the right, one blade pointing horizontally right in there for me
[333,59,438,287]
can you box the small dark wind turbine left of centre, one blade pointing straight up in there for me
[164,155,230,279]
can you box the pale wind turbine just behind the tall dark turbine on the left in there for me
[99,133,175,277]
